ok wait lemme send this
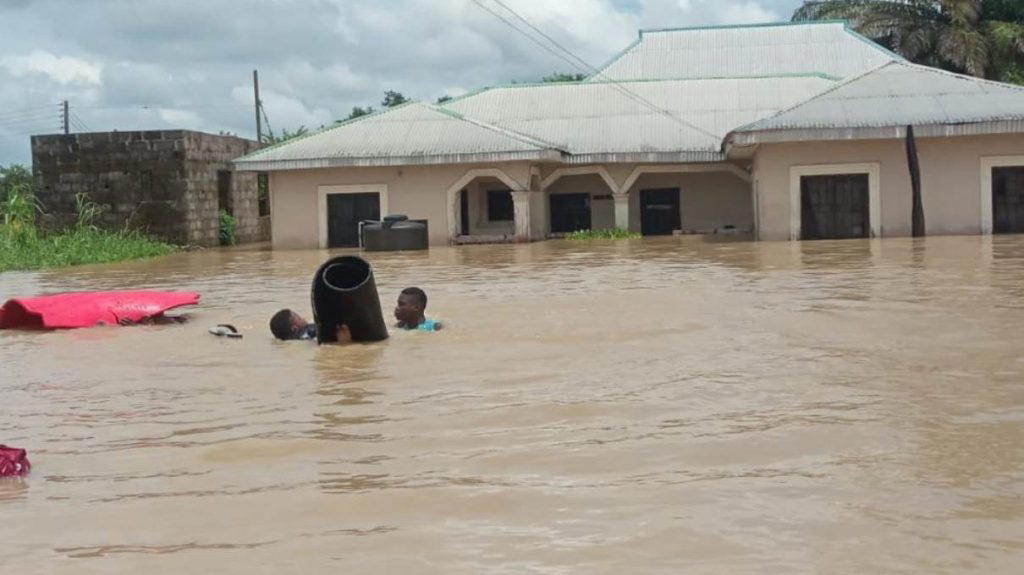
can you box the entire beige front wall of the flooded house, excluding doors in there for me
[270,131,1024,249]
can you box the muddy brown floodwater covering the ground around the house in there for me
[0,236,1024,575]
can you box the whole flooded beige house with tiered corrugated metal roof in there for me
[236,21,1024,248]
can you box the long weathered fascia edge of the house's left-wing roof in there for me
[234,149,563,172]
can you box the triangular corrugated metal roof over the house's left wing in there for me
[236,103,562,170]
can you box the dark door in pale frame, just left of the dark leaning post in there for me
[800,174,871,239]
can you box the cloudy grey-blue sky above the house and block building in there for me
[0,0,801,166]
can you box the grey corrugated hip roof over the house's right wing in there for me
[731,61,1024,144]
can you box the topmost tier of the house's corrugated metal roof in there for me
[592,21,902,81]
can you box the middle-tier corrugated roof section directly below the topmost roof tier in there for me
[445,76,835,162]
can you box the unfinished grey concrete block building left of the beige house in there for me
[32,130,269,247]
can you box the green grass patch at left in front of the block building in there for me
[0,187,178,272]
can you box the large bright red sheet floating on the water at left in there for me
[0,292,199,329]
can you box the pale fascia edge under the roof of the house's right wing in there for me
[725,118,1024,148]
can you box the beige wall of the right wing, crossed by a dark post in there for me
[754,134,1024,239]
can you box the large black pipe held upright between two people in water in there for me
[312,256,387,344]
